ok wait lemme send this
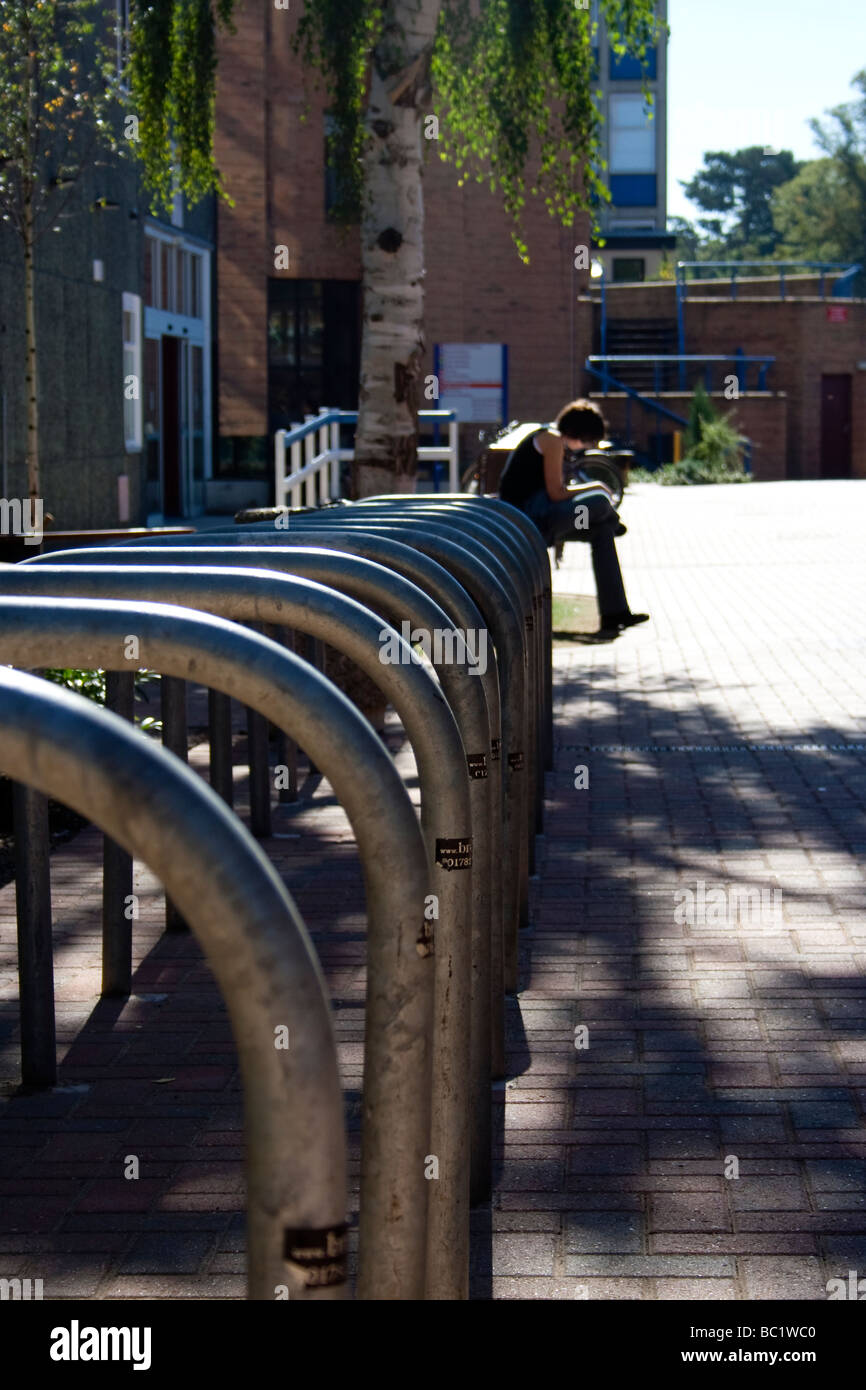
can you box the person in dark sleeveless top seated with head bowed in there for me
[499,400,649,637]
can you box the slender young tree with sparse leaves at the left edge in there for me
[0,0,118,511]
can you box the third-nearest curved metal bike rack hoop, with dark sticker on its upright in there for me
[18,569,475,1298]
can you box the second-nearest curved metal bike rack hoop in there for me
[0,600,436,1298]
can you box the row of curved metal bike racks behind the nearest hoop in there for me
[0,495,552,1300]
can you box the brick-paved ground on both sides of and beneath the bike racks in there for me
[0,482,866,1300]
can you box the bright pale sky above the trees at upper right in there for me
[667,0,866,220]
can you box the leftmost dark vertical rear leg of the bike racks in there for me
[12,783,57,1087]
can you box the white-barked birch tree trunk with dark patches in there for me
[352,0,442,496]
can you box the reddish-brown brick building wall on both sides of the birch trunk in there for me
[215,6,589,475]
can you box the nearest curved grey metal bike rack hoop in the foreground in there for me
[0,658,348,1302]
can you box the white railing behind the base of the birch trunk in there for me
[274,410,460,507]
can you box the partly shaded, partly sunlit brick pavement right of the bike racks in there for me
[475,482,866,1300]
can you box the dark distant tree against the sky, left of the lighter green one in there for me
[681,145,802,260]
